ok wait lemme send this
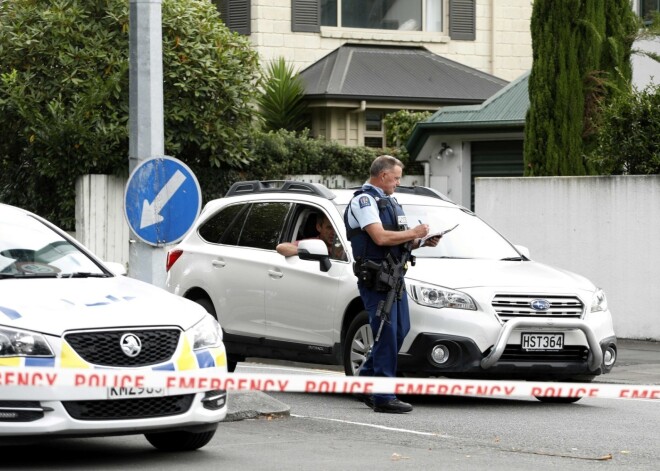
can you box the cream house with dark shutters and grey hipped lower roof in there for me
[212,0,532,147]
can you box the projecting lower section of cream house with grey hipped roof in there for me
[300,43,507,148]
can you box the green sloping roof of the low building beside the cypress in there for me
[406,72,529,158]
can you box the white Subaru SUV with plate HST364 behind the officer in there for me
[167,181,617,400]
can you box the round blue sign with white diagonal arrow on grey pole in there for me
[124,156,202,246]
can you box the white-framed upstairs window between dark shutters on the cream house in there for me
[321,0,443,32]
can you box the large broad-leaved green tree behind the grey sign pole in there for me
[0,0,258,229]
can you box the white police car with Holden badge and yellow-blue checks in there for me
[0,204,227,451]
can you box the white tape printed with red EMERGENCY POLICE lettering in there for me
[0,367,660,400]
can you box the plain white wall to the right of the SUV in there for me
[475,175,660,340]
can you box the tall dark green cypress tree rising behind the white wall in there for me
[524,0,637,175]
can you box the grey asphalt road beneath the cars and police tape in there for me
[0,341,660,471]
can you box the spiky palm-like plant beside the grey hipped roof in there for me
[258,57,307,132]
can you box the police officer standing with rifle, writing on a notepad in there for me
[344,155,439,413]
